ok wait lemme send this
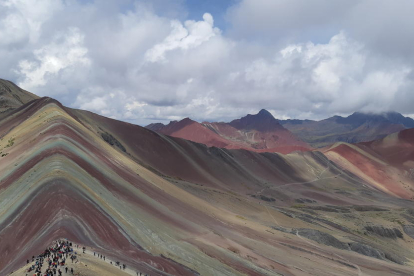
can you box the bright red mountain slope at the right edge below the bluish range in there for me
[325,129,414,199]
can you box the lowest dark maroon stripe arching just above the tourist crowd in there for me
[0,178,197,275]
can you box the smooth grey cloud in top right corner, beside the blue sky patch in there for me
[228,0,414,58]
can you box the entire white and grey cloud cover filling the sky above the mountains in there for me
[0,0,414,124]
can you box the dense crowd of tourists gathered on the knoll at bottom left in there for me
[26,240,76,276]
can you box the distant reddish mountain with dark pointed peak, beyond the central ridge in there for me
[147,109,310,154]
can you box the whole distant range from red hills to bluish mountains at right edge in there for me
[146,109,414,150]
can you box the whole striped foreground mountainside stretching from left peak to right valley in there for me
[0,98,414,275]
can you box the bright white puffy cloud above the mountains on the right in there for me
[233,33,411,115]
